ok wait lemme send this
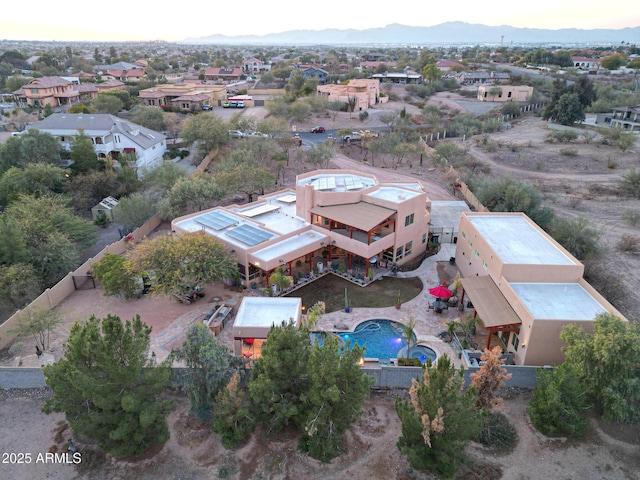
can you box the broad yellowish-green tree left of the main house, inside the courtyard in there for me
[128,232,238,295]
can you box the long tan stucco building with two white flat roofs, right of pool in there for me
[455,213,626,365]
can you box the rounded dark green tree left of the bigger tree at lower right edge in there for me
[527,365,589,436]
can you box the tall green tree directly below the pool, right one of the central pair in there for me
[300,335,371,462]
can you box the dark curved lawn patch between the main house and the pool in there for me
[288,275,423,313]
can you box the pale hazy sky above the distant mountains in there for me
[0,0,640,42]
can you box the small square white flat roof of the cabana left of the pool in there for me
[233,297,302,328]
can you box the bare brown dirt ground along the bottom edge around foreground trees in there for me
[0,390,640,480]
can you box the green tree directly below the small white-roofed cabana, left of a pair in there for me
[249,321,311,434]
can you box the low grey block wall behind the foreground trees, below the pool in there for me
[0,365,540,389]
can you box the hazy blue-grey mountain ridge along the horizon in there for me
[182,22,640,45]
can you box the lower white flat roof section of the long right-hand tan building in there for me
[509,282,607,321]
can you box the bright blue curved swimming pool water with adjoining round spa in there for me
[312,319,436,362]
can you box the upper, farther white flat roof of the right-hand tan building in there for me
[467,214,575,265]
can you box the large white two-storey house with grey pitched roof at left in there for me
[27,113,167,172]
